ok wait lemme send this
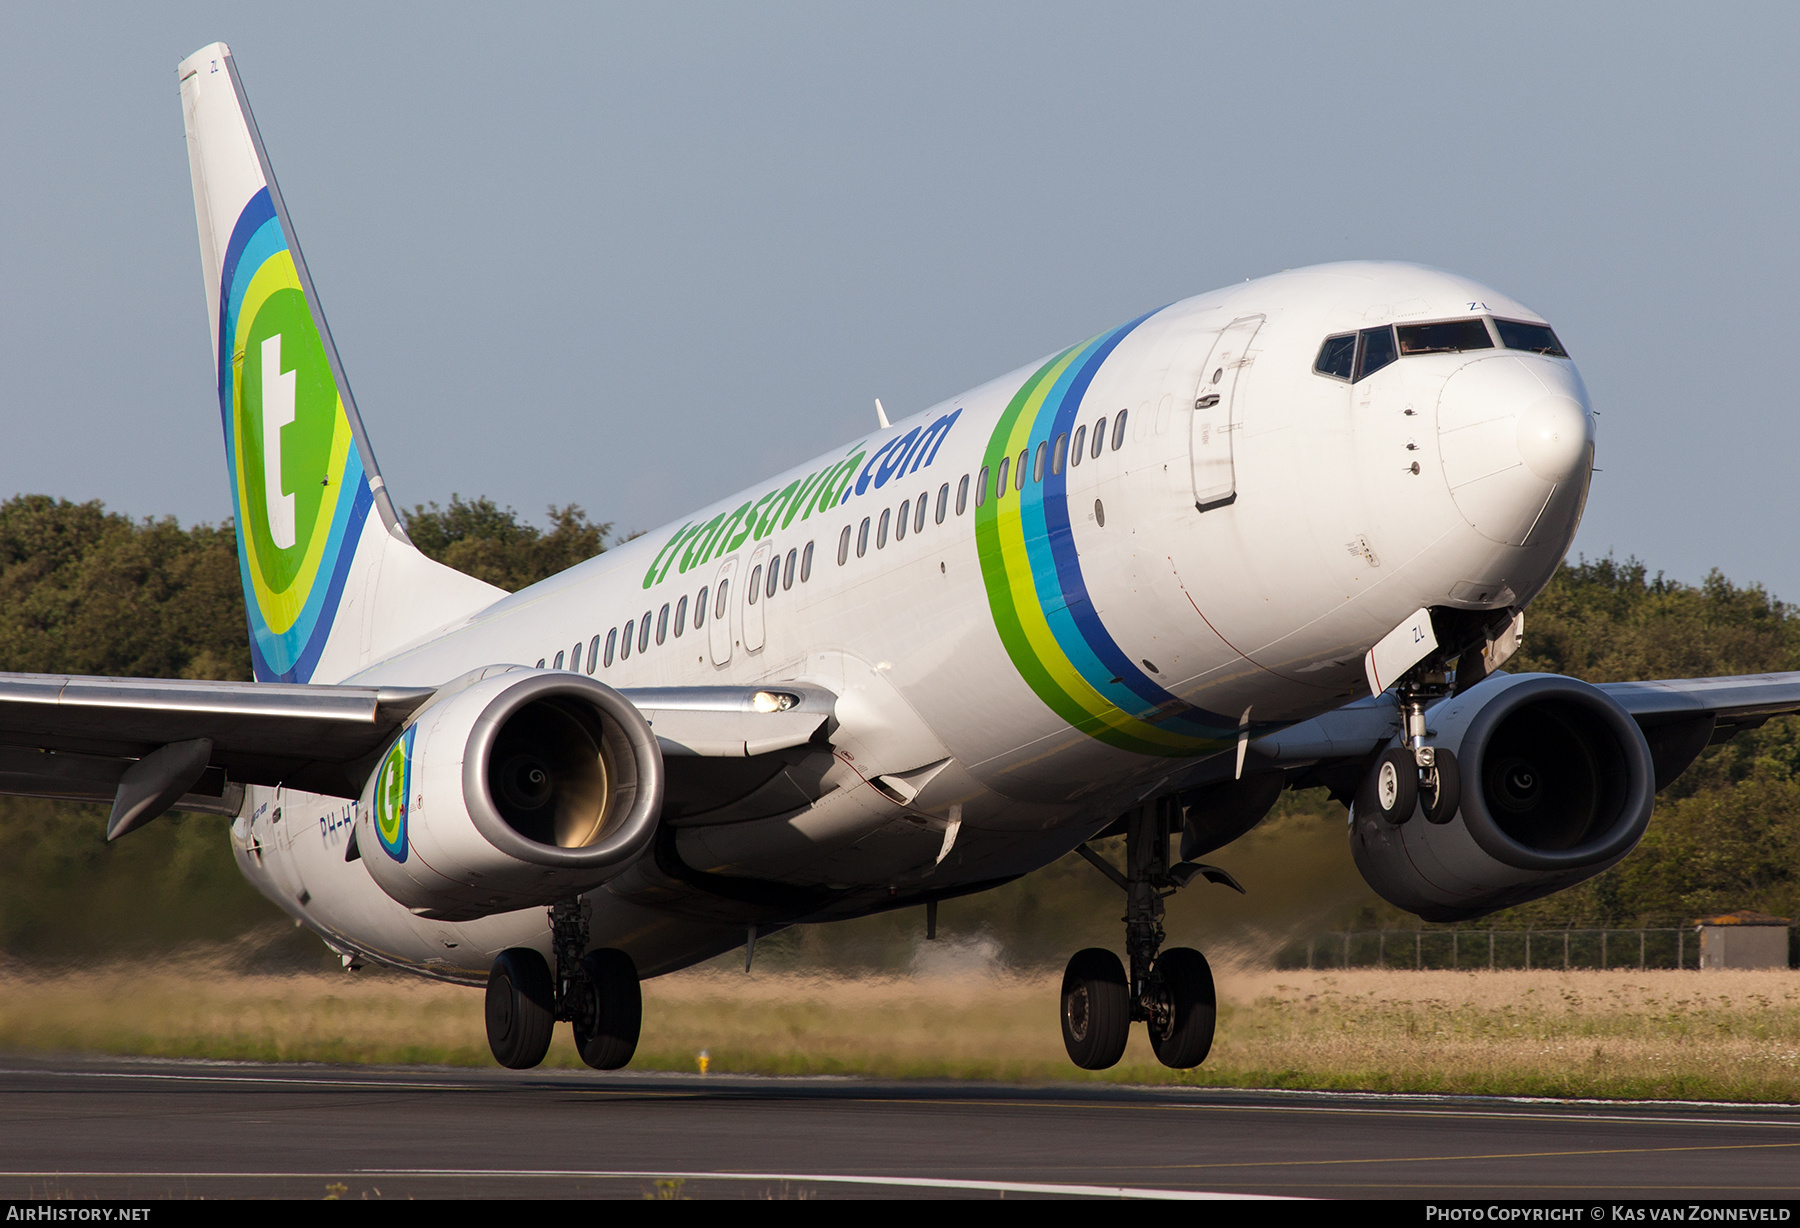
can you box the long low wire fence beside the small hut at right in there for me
[1274,926,1699,969]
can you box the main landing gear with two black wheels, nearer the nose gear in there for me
[1062,798,1244,1070]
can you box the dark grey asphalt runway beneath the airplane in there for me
[0,1055,1800,1203]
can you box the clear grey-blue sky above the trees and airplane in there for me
[0,2,1800,600]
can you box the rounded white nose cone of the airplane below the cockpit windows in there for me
[1438,355,1593,546]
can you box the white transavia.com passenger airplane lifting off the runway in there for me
[0,43,1800,1070]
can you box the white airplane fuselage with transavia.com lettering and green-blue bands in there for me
[234,263,1593,980]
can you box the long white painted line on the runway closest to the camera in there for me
[0,1169,1287,1201]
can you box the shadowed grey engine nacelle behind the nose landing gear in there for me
[1350,673,1656,922]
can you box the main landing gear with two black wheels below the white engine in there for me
[486,900,644,1070]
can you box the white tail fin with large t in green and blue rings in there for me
[180,43,504,682]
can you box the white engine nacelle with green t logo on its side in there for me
[356,670,662,920]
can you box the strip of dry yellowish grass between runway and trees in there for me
[0,960,1800,1102]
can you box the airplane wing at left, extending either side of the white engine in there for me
[0,673,835,835]
